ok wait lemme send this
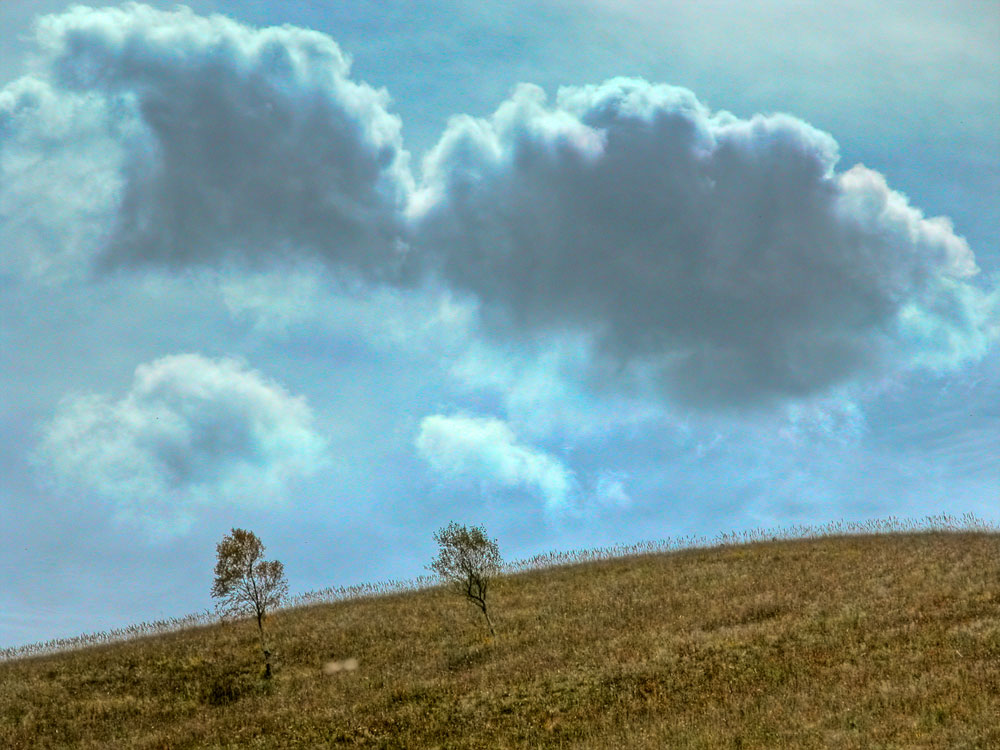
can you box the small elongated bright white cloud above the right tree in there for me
[416,414,576,511]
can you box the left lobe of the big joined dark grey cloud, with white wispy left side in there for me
[0,5,409,273]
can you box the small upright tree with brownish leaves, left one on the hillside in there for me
[212,529,288,678]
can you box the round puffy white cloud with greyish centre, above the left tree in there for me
[36,354,325,533]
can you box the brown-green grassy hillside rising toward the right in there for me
[0,532,1000,748]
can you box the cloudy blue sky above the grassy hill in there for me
[0,0,1000,646]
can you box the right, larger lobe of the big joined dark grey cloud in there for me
[410,79,990,407]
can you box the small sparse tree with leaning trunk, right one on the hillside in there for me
[429,521,502,636]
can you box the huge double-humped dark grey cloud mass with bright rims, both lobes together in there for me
[0,6,996,408]
